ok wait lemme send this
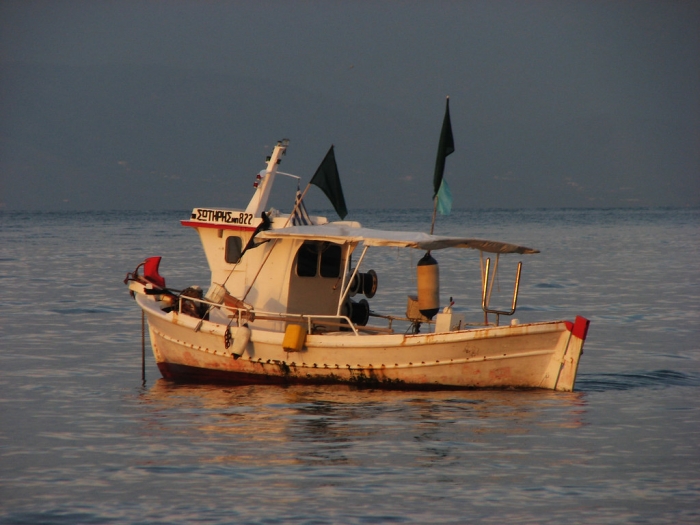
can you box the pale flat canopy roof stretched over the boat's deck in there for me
[257,223,539,254]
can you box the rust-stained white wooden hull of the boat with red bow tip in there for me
[138,296,588,391]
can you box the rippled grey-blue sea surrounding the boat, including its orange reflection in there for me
[0,209,700,524]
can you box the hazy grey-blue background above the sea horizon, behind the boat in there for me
[0,0,700,211]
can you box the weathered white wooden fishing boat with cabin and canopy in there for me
[125,135,589,391]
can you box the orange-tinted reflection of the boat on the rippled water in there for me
[141,379,586,469]
